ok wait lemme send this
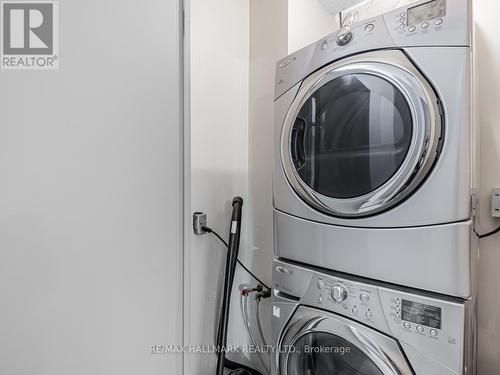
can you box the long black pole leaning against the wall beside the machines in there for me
[216,197,243,375]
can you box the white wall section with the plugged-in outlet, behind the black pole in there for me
[185,0,249,375]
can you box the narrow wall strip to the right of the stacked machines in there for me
[475,0,500,375]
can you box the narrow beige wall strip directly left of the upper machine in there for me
[248,0,288,304]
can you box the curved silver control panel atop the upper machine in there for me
[275,0,472,99]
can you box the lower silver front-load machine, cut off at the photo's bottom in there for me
[272,260,476,375]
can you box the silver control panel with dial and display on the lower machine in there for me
[273,260,471,373]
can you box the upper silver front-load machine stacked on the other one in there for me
[274,0,478,297]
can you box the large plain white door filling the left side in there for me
[0,0,182,375]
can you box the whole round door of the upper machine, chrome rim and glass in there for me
[281,51,442,217]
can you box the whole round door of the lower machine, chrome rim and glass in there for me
[277,307,414,375]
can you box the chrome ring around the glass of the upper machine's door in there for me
[281,50,443,218]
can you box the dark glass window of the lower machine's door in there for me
[286,332,384,375]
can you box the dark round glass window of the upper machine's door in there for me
[291,74,413,198]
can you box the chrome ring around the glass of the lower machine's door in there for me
[276,306,414,375]
